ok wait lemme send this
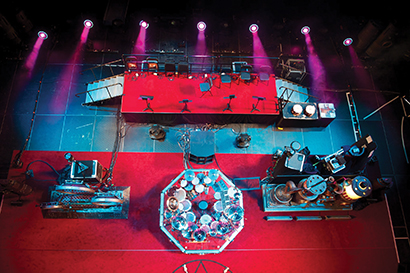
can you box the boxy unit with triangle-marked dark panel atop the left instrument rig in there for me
[70,160,103,183]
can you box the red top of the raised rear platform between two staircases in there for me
[121,72,279,115]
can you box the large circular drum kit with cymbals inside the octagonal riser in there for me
[164,170,244,242]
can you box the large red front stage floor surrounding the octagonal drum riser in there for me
[0,151,397,273]
